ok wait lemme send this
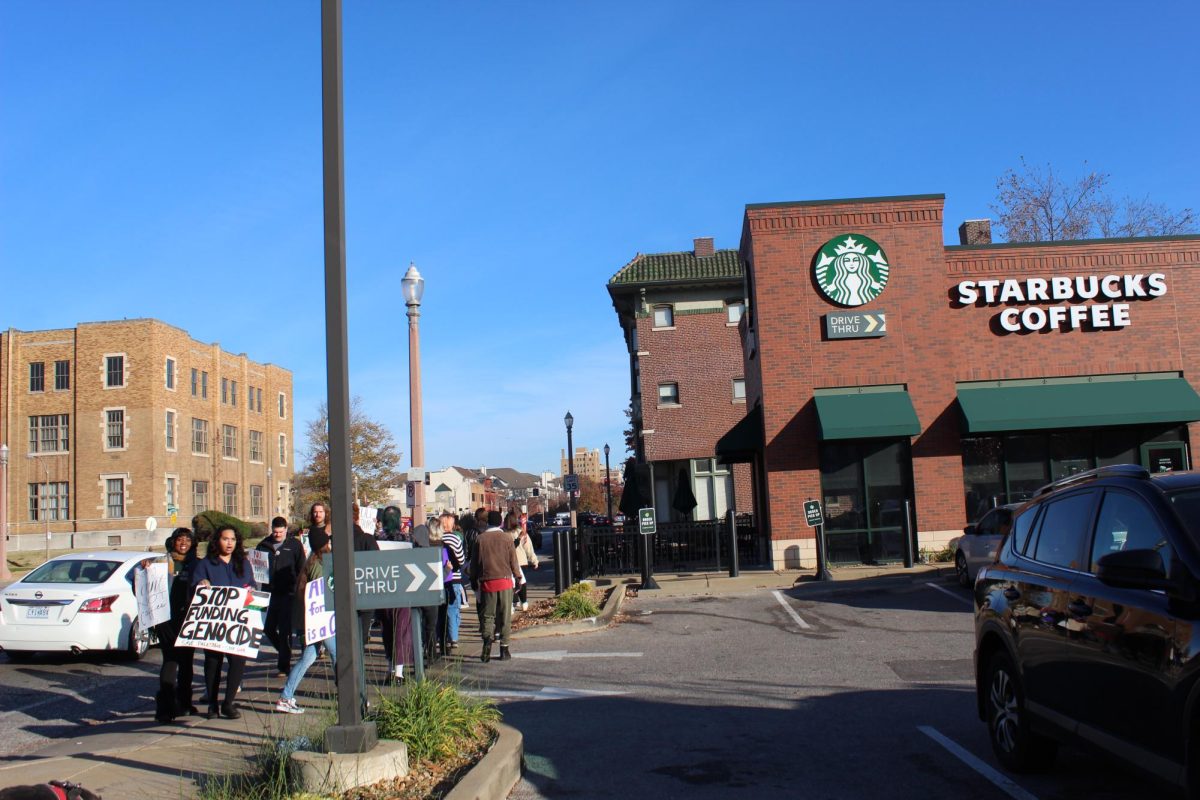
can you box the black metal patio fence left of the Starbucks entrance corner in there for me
[575,515,770,578]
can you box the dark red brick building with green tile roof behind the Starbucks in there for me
[609,237,755,522]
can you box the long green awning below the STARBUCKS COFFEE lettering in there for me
[958,378,1200,433]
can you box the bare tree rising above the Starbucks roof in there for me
[991,157,1196,241]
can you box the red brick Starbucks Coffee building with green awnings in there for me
[718,194,1200,567]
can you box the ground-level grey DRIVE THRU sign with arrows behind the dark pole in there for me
[324,547,445,610]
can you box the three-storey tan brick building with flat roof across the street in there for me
[0,319,294,549]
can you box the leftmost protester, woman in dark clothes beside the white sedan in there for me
[154,528,197,722]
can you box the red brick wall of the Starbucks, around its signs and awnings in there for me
[742,198,1200,539]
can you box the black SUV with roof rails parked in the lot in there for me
[974,464,1200,798]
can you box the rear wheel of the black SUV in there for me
[986,651,1058,772]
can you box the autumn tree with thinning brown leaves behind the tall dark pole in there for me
[294,397,402,512]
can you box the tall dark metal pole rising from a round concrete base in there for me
[320,0,377,753]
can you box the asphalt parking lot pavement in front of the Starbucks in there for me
[499,582,1172,800]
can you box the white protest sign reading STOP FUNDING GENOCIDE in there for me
[175,587,271,658]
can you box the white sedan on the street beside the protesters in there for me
[0,551,155,660]
